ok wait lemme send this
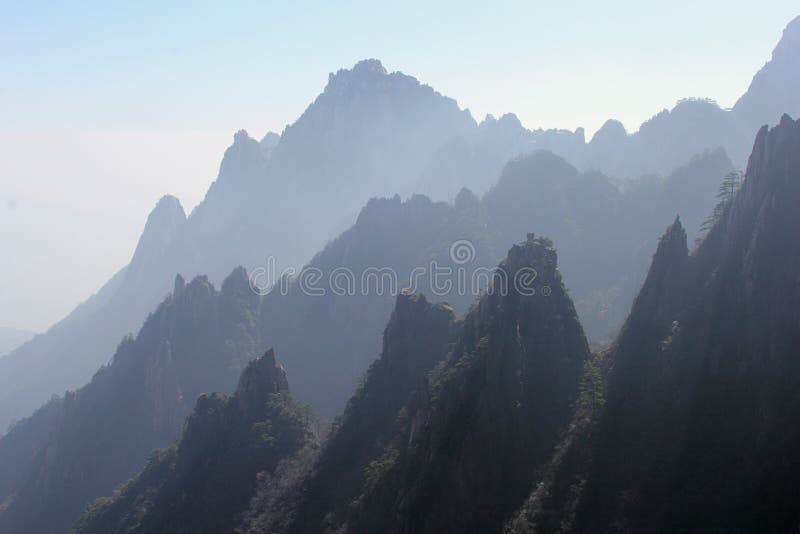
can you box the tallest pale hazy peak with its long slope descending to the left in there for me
[0,60,488,432]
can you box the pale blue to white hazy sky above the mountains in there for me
[0,0,800,330]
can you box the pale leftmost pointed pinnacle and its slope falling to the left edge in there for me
[0,197,185,435]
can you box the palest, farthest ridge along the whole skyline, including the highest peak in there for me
[6,15,800,431]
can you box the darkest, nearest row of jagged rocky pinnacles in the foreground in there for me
[72,108,800,533]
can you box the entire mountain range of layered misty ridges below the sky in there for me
[0,12,800,533]
